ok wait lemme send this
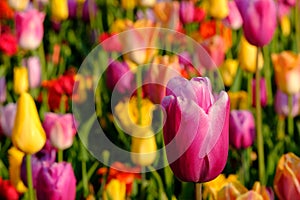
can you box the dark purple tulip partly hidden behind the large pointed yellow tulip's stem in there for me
[21,140,56,188]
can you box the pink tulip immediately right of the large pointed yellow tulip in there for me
[43,113,77,150]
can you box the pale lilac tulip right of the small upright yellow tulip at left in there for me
[22,56,42,88]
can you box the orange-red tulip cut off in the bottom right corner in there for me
[274,153,300,200]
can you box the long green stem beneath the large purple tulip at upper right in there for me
[255,48,265,185]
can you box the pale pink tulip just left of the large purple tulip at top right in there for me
[223,1,243,30]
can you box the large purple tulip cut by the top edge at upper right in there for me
[235,0,276,47]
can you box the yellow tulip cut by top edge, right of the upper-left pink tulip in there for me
[51,0,69,21]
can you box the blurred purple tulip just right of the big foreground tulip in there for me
[229,110,255,149]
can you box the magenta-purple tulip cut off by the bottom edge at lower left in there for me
[36,162,76,200]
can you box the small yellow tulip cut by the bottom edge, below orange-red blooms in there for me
[103,179,126,200]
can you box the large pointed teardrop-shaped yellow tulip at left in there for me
[12,92,46,154]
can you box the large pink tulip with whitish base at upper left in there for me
[15,9,45,50]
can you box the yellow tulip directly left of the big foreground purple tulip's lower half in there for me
[131,130,157,166]
